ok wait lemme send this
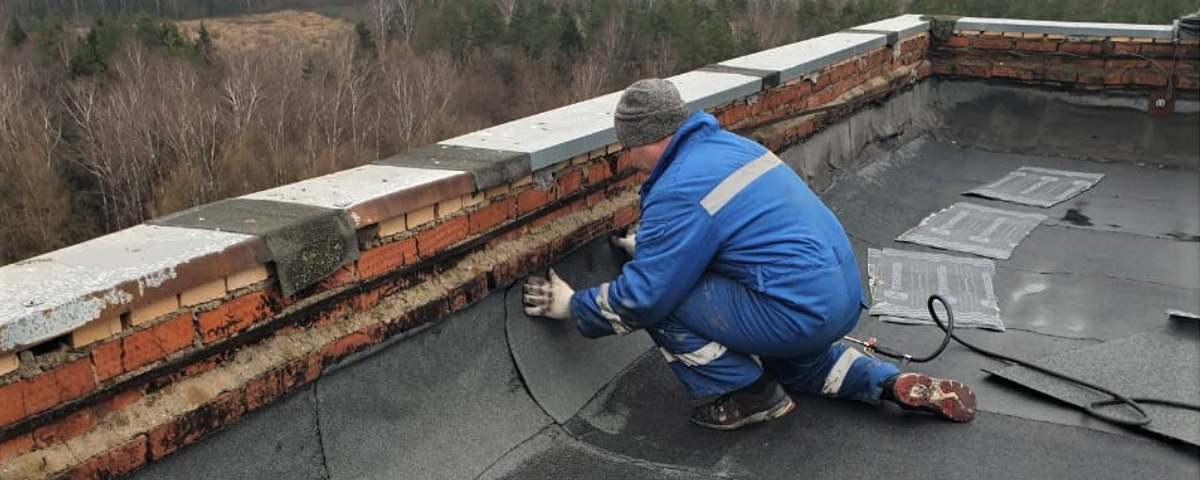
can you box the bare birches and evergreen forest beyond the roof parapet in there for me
[0,0,1200,264]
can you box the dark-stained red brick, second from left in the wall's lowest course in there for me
[148,390,246,460]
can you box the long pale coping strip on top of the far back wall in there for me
[954,17,1175,38]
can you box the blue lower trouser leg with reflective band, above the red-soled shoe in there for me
[762,343,900,404]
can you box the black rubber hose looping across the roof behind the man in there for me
[916,294,1200,426]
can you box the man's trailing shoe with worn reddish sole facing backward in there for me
[882,373,976,421]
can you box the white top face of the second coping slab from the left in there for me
[241,164,463,227]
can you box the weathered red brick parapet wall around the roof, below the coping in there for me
[0,16,1196,478]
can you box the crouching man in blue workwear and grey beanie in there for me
[522,79,976,430]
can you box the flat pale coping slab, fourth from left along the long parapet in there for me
[720,32,888,83]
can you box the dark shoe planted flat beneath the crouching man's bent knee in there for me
[691,380,796,430]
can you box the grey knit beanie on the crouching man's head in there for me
[614,78,688,148]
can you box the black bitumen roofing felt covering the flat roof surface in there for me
[124,84,1200,480]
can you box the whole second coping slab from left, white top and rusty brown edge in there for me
[241,164,474,228]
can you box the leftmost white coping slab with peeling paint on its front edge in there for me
[0,224,256,350]
